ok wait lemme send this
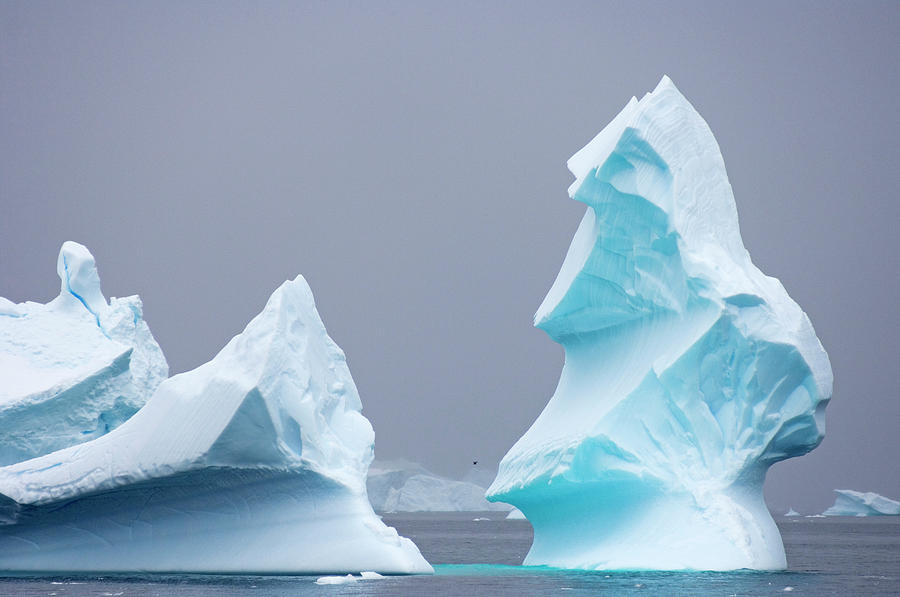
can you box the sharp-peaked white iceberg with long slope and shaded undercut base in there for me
[0,276,433,574]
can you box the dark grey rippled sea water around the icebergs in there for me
[0,512,900,597]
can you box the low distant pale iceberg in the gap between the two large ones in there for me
[366,460,511,512]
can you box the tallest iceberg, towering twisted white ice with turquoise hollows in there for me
[488,77,832,570]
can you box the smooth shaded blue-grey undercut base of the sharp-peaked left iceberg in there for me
[0,469,431,574]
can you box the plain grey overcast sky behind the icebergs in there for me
[0,0,900,512]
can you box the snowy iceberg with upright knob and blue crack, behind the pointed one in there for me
[0,241,169,465]
